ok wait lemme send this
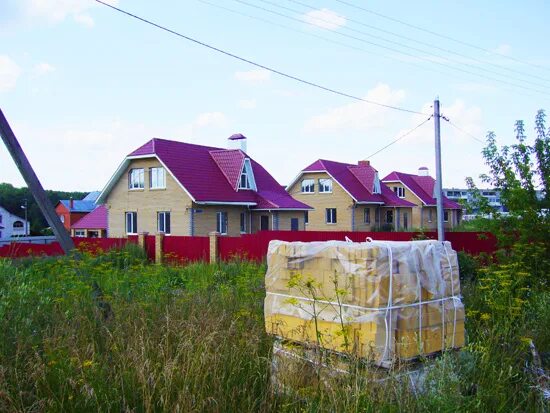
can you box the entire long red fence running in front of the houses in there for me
[0,231,497,264]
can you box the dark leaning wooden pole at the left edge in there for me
[0,109,75,254]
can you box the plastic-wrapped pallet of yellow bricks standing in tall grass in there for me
[264,241,465,367]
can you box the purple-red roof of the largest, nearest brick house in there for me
[96,138,311,210]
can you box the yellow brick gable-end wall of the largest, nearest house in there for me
[105,158,191,237]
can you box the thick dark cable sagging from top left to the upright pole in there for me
[95,0,426,115]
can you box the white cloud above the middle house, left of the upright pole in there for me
[305,84,405,133]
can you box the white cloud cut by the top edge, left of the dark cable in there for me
[22,0,118,27]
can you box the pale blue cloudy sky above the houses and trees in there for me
[0,0,550,191]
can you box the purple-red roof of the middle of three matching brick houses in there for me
[291,159,414,207]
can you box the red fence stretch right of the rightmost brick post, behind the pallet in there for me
[219,231,497,260]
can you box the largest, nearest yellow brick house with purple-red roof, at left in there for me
[97,134,311,237]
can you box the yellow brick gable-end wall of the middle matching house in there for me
[288,172,357,231]
